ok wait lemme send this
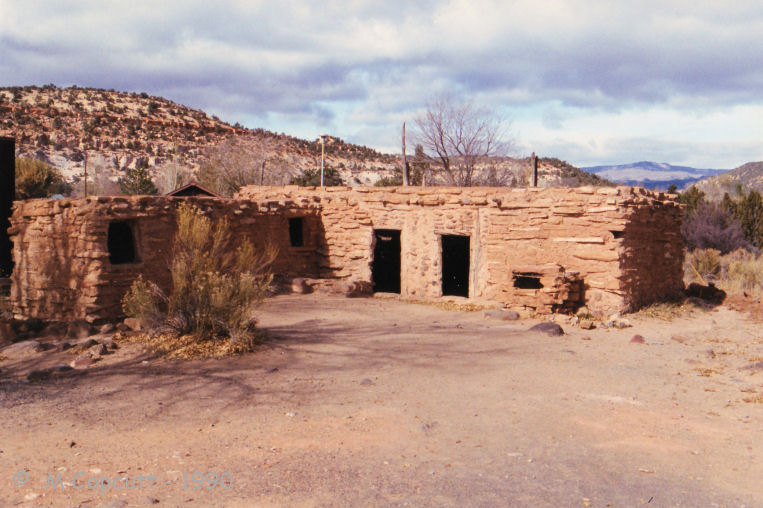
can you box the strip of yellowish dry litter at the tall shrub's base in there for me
[115,333,263,360]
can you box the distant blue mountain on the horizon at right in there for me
[580,161,728,189]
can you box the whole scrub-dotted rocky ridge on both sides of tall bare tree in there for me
[0,85,611,195]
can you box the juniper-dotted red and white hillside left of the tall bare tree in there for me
[0,85,396,193]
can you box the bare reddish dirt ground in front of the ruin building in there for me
[0,295,763,507]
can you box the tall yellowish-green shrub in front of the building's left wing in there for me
[122,204,276,343]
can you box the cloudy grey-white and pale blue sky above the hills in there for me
[0,0,763,168]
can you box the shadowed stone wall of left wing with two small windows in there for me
[9,196,321,321]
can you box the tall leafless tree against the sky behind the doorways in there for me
[416,95,510,187]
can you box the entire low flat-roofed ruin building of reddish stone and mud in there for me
[9,186,683,321]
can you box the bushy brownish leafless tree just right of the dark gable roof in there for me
[198,136,296,196]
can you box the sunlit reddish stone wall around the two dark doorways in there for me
[238,186,683,313]
